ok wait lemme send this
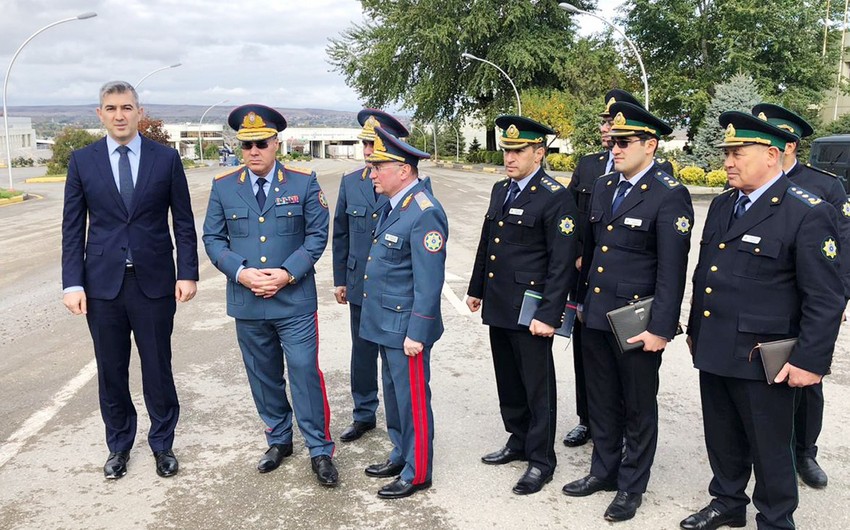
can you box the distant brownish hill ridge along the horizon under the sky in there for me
[9,103,372,137]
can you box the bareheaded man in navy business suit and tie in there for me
[62,81,198,479]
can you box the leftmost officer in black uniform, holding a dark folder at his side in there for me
[466,116,578,495]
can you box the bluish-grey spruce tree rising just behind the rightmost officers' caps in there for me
[692,75,762,171]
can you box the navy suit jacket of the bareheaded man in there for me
[62,137,198,300]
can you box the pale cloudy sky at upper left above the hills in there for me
[0,0,620,111]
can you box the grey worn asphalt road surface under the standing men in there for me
[0,160,850,529]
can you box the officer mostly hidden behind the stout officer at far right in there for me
[752,103,850,488]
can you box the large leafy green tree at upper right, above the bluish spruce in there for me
[622,0,838,138]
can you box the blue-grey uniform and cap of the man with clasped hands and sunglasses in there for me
[203,105,334,457]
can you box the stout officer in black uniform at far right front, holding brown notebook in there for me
[680,111,844,529]
